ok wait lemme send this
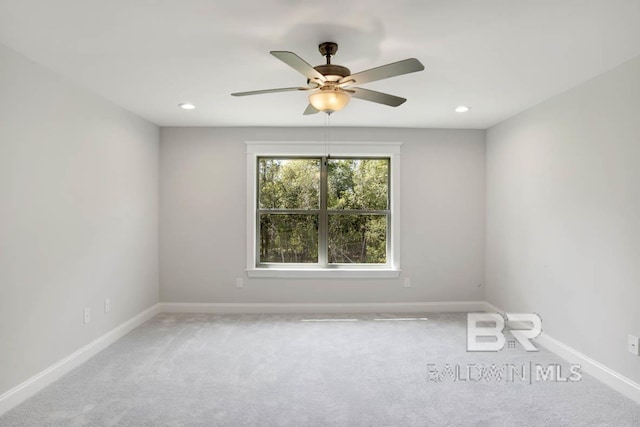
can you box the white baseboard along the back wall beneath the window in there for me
[159,301,485,314]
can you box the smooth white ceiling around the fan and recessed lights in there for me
[0,0,640,129]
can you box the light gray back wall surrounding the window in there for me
[160,128,485,303]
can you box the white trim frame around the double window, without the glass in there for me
[246,141,402,278]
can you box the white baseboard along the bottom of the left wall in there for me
[0,304,160,415]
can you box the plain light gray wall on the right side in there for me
[486,58,640,382]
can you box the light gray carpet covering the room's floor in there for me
[0,313,640,427]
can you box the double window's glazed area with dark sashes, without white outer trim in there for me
[256,157,390,267]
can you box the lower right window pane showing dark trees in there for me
[328,214,387,264]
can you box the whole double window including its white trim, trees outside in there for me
[247,143,399,277]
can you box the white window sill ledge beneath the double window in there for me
[246,268,402,279]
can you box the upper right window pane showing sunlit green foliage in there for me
[327,159,389,210]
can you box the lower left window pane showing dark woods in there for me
[259,214,318,263]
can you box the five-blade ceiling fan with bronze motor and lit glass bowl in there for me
[231,42,424,115]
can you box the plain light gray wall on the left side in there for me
[0,45,158,394]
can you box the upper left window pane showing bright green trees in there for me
[258,158,320,209]
